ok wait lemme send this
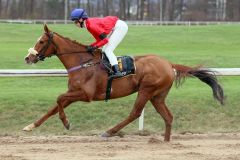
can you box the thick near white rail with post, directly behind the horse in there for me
[0,68,240,131]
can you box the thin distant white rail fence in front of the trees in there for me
[0,19,240,26]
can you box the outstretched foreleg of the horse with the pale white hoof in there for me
[23,101,72,131]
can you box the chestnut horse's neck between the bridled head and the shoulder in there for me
[55,36,101,69]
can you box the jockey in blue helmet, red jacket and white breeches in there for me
[71,9,128,76]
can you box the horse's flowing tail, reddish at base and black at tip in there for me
[172,64,224,105]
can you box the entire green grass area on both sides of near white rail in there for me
[0,24,240,135]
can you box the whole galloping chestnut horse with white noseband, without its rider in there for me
[23,25,224,141]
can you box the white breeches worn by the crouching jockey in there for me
[102,20,128,66]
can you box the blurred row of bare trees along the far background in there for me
[0,0,240,21]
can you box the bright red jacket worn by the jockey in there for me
[85,16,118,48]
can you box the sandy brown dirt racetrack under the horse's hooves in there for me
[0,133,240,160]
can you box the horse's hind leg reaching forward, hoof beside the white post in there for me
[102,92,150,137]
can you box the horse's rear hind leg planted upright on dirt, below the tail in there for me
[150,94,173,141]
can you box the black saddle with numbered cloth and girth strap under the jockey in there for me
[102,52,136,101]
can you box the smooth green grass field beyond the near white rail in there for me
[0,24,240,69]
